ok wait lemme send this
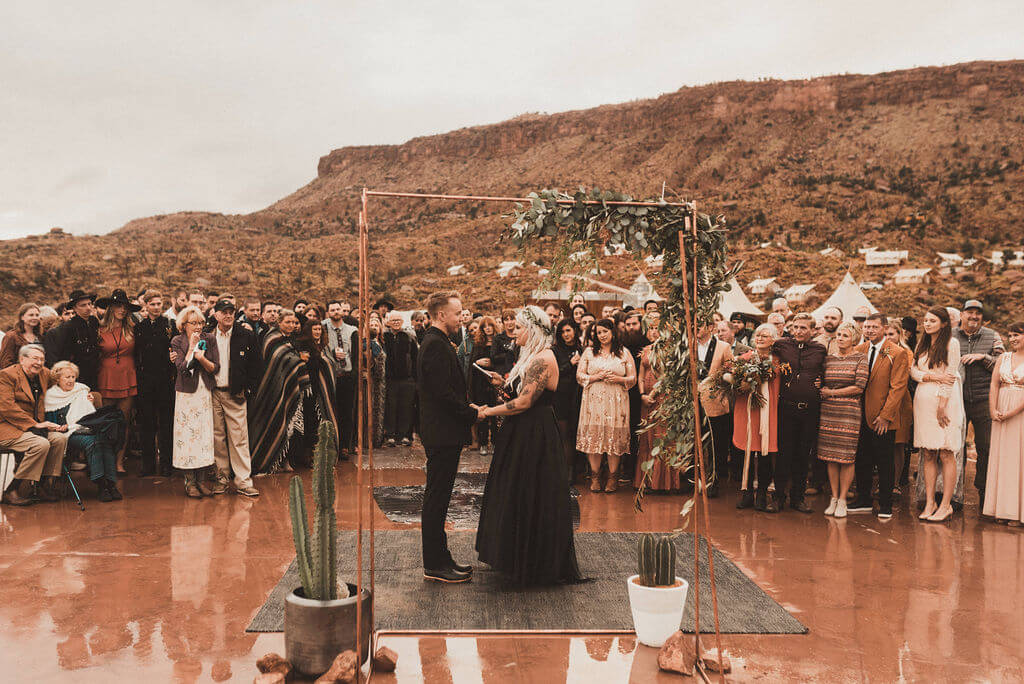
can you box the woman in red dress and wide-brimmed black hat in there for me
[96,290,142,473]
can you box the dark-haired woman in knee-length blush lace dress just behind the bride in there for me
[577,318,637,491]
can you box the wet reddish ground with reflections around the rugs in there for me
[0,453,1024,684]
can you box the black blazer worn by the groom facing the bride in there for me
[416,326,478,448]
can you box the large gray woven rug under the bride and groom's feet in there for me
[246,529,807,634]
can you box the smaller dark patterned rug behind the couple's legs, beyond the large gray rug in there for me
[374,472,580,529]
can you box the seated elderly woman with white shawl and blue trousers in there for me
[45,361,122,502]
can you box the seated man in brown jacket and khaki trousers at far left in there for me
[0,344,68,506]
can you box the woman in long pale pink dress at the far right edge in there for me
[982,323,1024,526]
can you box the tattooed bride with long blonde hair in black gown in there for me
[471,306,583,586]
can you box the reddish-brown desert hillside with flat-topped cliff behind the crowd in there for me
[0,61,1024,325]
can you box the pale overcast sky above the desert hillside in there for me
[0,0,1024,239]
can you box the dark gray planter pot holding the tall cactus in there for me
[285,584,374,677]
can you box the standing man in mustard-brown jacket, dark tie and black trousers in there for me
[847,313,910,520]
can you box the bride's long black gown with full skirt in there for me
[476,389,583,586]
